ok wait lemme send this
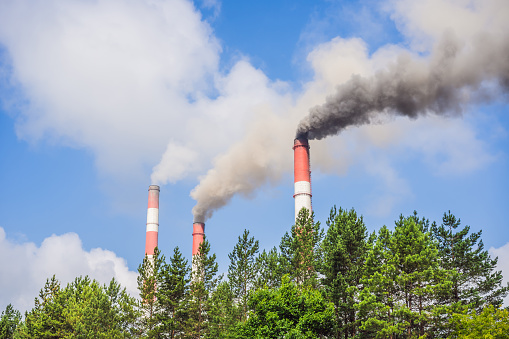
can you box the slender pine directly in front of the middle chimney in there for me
[184,239,219,339]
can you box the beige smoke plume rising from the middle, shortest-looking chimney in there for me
[191,115,291,222]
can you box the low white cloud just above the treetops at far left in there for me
[0,227,138,311]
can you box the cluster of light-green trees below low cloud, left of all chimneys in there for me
[17,276,140,338]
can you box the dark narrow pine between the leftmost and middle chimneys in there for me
[155,247,191,339]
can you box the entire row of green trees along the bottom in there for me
[0,207,509,339]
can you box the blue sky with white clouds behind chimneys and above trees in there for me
[0,0,509,310]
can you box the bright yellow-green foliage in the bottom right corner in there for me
[449,305,509,339]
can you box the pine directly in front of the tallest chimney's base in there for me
[279,208,323,287]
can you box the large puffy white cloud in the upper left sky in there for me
[0,0,221,176]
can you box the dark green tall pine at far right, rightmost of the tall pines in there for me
[431,211,509,311]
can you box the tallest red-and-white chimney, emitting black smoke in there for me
[293,137,311,220]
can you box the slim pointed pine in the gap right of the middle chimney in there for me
[228,230,260,321]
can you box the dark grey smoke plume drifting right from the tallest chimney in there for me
[296,33,509,139]
